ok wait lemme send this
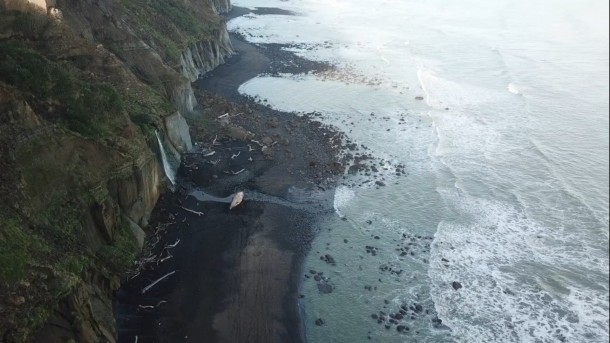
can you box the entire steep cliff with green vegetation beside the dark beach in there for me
[0,0,232,342]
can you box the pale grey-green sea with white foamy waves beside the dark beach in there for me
[229,0,609,342]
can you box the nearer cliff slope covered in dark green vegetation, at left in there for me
[0,8,159,342]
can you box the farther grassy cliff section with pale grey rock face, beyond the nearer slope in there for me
[56,0,233,113]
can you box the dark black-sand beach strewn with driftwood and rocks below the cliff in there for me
[115,9,343,342]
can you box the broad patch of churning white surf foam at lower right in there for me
[429,194,609,342]
